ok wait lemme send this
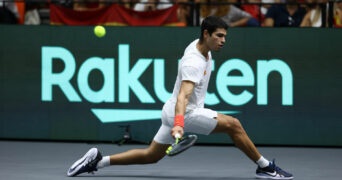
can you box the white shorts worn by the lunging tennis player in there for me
[154,102,217,144]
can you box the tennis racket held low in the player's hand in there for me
[166,134,197,156]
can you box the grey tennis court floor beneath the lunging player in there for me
[0,141,342,180]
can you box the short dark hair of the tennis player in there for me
[200,16,228,41]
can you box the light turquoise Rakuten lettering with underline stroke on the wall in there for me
[41,44,293,122]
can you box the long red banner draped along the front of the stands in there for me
[50,4,184,26]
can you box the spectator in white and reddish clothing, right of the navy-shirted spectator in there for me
[300,0,327,27]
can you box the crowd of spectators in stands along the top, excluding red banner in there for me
[0,0,342,27]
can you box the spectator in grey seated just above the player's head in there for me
[200,0,259,27]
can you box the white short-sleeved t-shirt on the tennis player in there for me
[171,39,212,111]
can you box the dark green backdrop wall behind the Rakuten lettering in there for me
[0,25,342,146]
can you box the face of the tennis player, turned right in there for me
[207,28,227,51]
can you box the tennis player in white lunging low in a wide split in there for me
[67,16,293,179]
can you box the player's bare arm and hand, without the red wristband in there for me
[171,81,195,137]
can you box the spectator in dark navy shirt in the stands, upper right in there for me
[264,0,306,27]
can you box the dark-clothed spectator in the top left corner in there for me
[0,1,19,24]
